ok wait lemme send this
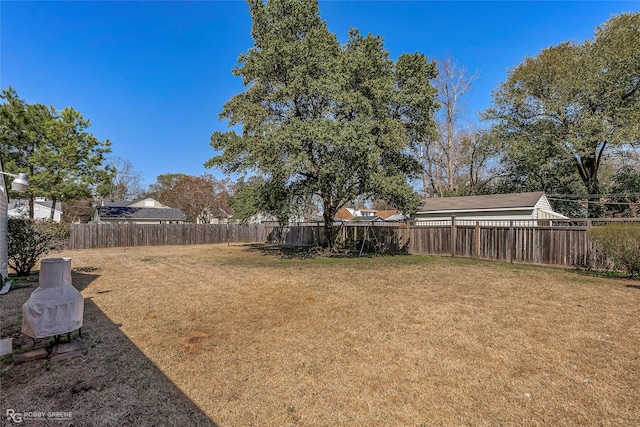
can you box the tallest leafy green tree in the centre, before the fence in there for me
[205,0,435,242]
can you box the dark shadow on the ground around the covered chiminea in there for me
[0,269,216,426]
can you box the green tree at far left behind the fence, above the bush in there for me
[0,88,111,218]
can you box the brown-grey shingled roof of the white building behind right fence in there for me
[418,191,544,212]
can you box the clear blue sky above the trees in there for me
[0,0,640,185]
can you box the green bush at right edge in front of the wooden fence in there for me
[588,223,640,278]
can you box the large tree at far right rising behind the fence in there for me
[487,13,640,215]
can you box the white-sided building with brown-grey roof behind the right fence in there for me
[412,191,569,226]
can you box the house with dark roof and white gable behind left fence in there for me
[93,198,187,224]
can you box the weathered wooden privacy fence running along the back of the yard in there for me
[67,218,640,268]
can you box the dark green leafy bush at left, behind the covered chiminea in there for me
[8,218,69,276]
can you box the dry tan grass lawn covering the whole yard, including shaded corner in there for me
[0,245,640,426]
